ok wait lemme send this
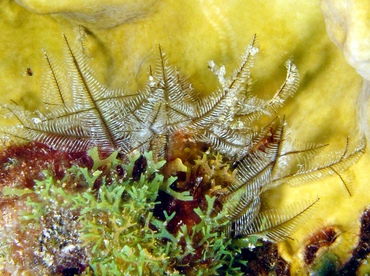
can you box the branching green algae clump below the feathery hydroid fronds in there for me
[3,148,264,275]
